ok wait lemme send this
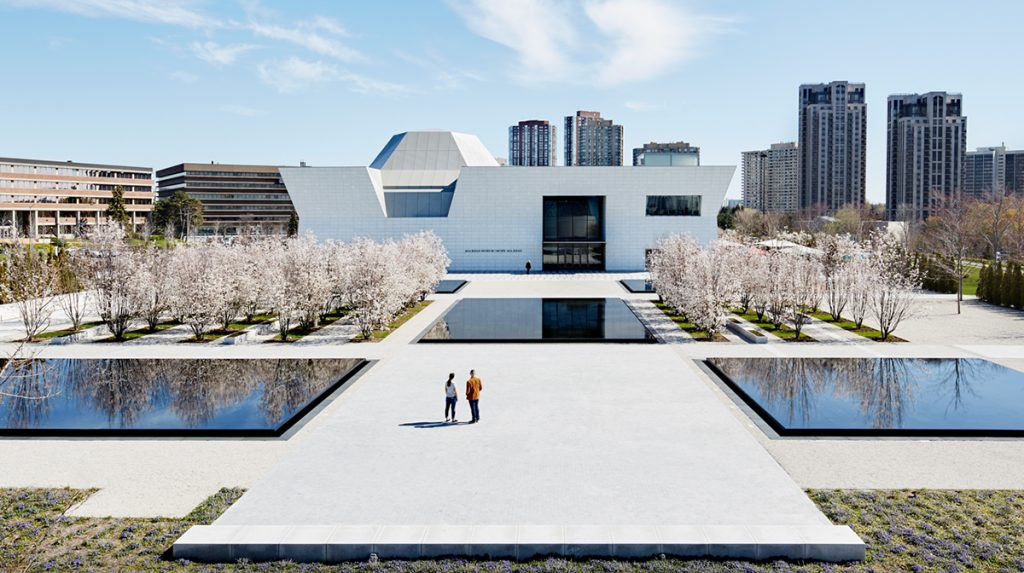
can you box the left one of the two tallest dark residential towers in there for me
[799,82,867,213]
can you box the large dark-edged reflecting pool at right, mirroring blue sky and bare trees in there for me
[707,358,1024,436]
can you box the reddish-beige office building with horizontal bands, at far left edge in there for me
[0,158,154,238]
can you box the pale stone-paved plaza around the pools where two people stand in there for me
[0,274,1024,560]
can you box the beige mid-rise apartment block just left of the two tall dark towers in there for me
[742,141,800,213]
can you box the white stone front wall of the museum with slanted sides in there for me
[281,132,735,271]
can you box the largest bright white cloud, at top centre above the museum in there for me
[450,0,729,86]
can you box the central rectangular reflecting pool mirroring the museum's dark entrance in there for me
[419,299,655,343]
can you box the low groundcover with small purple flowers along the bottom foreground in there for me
[0,489,1024,573]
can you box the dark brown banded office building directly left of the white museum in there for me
[157,163,293,235]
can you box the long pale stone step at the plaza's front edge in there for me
[172,525,865,563]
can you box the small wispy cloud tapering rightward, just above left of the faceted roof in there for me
[257,56,411,95]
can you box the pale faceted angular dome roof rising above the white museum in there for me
[370,131,498,188]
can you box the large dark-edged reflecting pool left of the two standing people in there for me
[0,358,366,436]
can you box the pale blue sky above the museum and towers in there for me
[0,0,1024,202]
